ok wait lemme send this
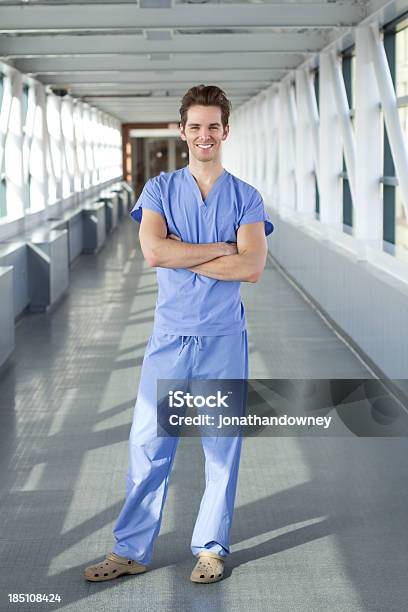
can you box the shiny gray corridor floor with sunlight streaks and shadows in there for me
[0,219,408,612]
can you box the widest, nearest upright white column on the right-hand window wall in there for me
[354,26,382,252]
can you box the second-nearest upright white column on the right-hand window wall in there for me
[319,52,343,233]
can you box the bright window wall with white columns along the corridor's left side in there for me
[0,68,122,223]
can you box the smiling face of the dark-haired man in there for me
[180,105,229,162]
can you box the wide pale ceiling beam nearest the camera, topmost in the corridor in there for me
[0,0,366,33]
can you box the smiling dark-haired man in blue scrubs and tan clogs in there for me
[84,85,273,583]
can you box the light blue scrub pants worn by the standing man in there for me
[113,330,248,565]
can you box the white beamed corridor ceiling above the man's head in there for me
[0,0,408,123]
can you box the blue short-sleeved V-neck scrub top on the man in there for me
[130,166,274,336]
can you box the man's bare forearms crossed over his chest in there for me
[139,209,268,283]
